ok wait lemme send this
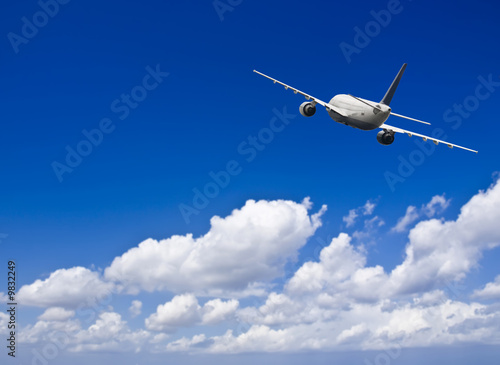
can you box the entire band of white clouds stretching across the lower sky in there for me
[13,183,500,353]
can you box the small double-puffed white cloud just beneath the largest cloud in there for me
[145,294,239,332]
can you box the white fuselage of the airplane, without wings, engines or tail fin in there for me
[328,94,391,131]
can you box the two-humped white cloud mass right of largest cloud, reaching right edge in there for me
[286,178,500,301]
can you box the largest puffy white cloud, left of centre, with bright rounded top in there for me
[105,200,326,297]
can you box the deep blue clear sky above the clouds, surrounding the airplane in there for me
[0,0,500,362]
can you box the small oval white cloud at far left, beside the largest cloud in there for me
[18,267,113,308]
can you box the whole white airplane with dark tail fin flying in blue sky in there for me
[253,63,477,153]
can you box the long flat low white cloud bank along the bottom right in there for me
[173,300,500,353]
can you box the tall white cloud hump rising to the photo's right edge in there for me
[390,182,500,294]
